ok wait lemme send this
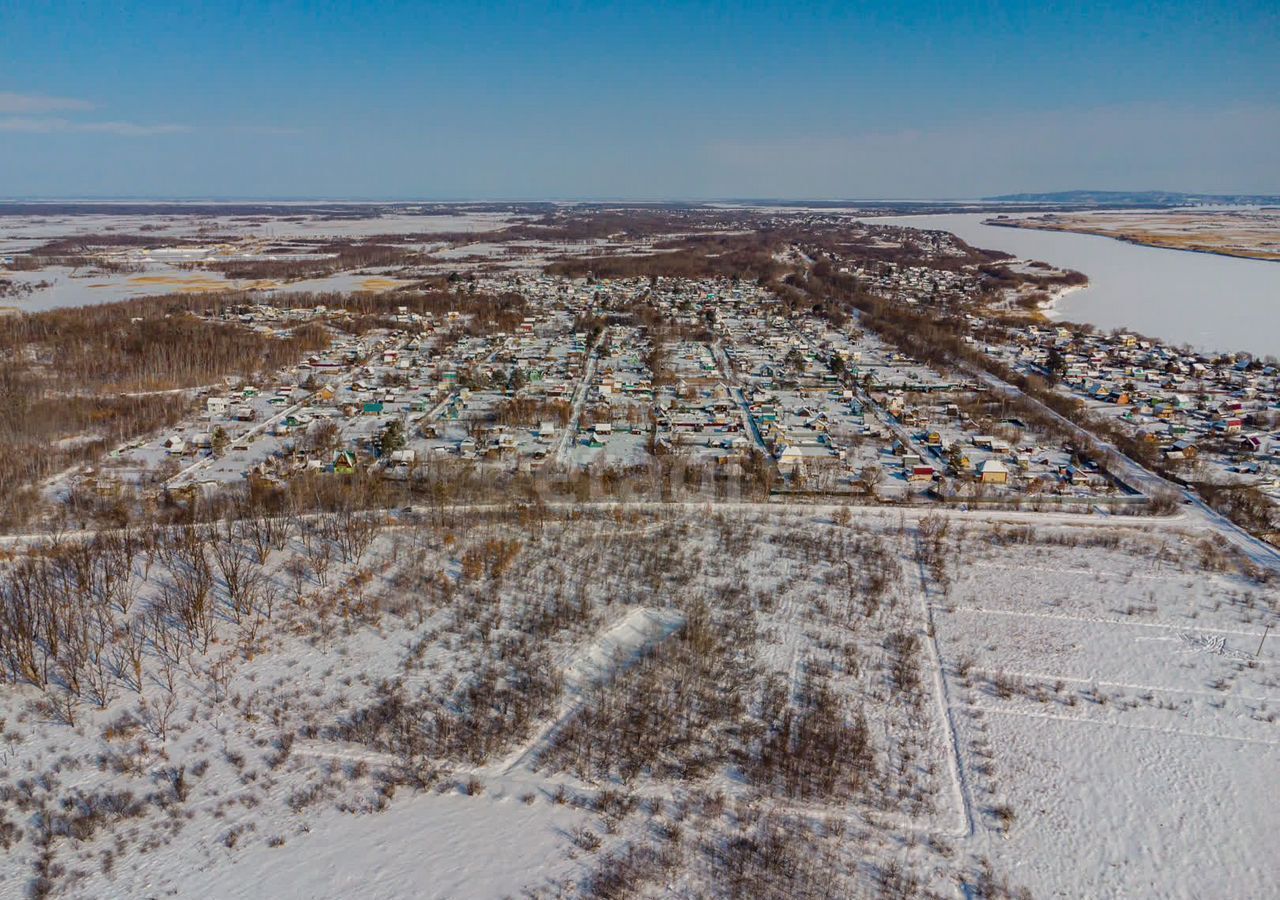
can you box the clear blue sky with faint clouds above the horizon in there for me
[0,0,1280,198]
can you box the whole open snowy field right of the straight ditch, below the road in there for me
[932,529,1280,896]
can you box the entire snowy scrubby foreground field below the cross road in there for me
[0,504,1280,897]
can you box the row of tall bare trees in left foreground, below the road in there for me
[0,510,380,719]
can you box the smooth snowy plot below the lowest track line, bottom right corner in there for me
[960,711,1280,897]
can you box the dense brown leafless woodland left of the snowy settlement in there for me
[0,302,329,529]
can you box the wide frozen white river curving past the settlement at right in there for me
[865,213,1280,356]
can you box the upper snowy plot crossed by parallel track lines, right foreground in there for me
[936,527,1280,711]
